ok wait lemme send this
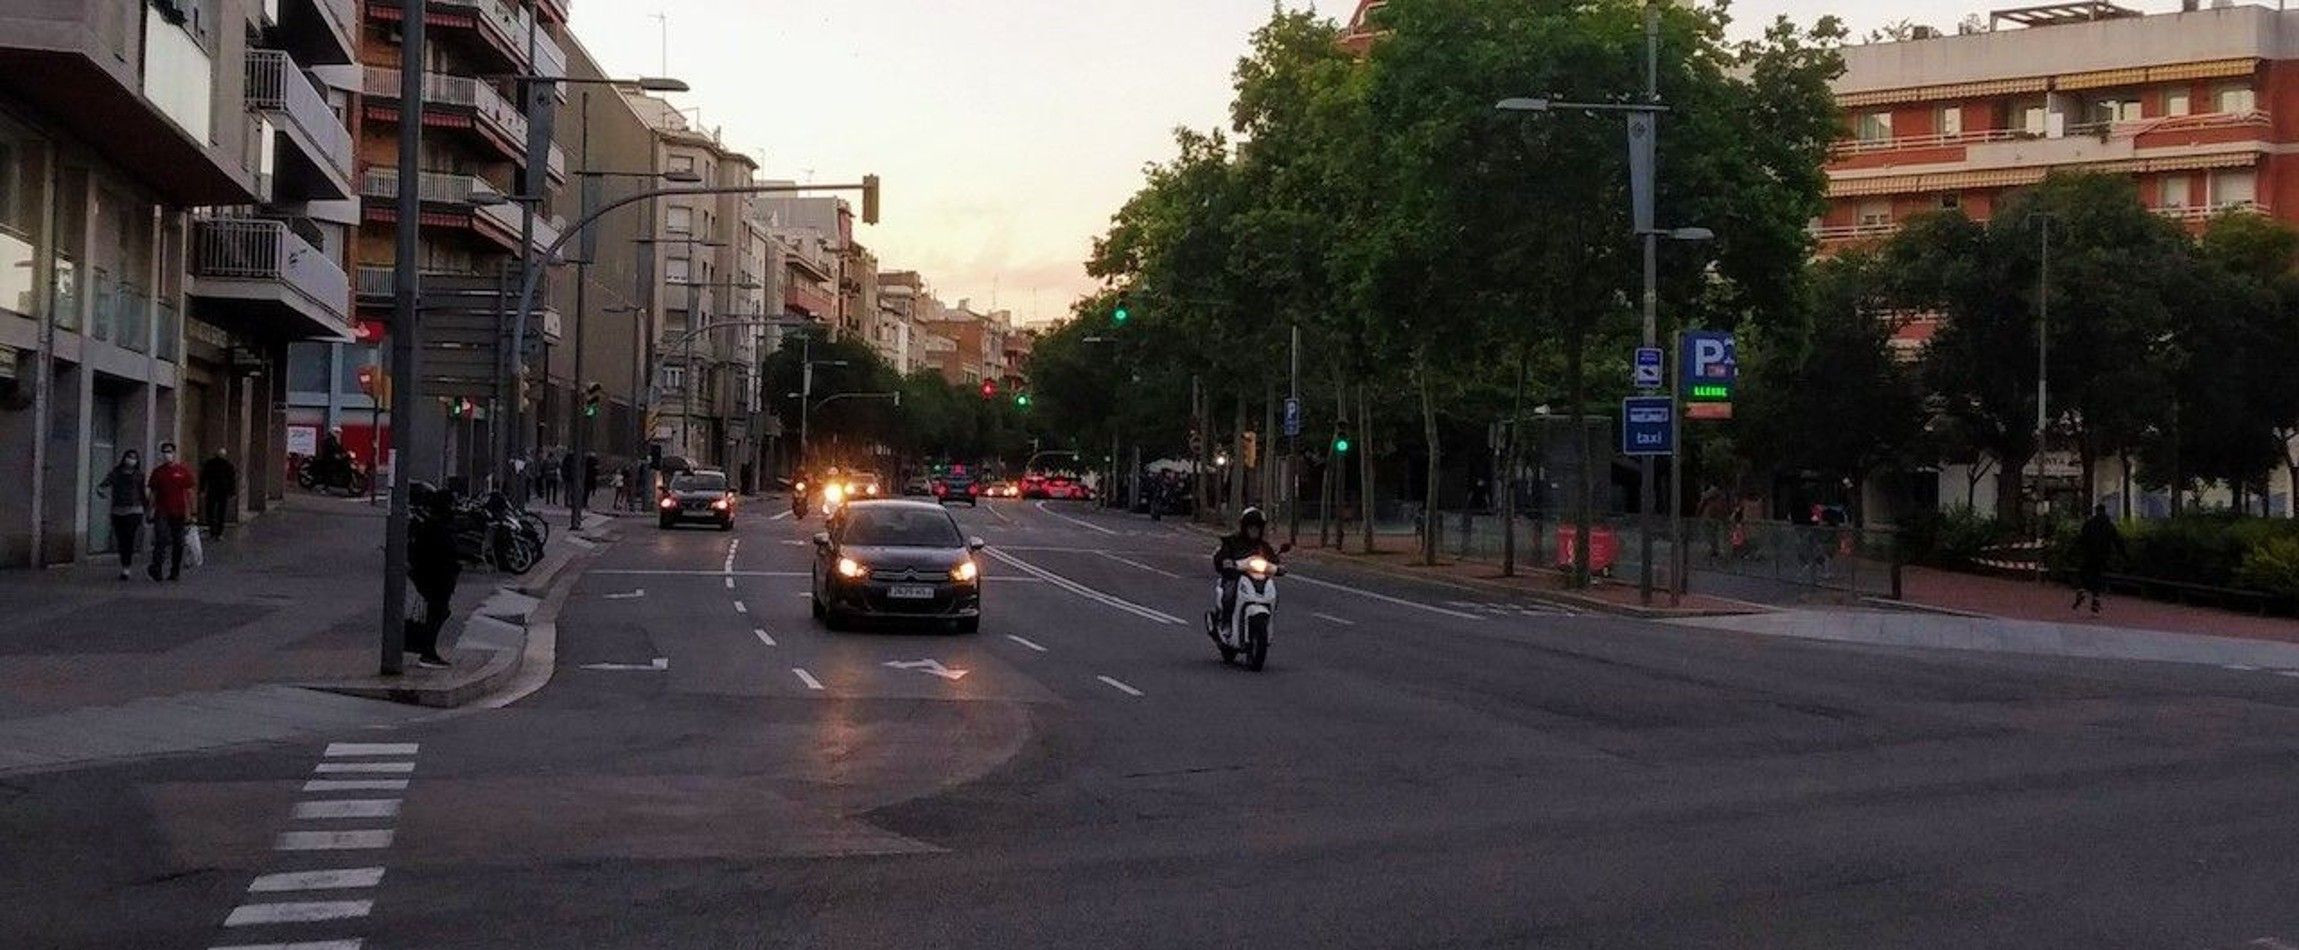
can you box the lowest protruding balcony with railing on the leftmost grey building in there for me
[186,219,352,340]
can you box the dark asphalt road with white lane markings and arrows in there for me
[13,501,2299,950]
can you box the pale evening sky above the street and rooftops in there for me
[572,0,1977,322]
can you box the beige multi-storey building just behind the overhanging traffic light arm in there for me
[630,97,775,472]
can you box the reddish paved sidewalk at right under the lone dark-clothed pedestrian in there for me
[1901,568,2299,642]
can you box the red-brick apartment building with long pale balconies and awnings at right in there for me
[1812,0,2299,253]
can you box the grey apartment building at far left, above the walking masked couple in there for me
[0,0,359,566]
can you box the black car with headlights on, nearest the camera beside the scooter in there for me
[812,499,982,633]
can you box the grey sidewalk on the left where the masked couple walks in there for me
[0,495,602,771]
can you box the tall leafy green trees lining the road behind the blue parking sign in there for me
[1032,0,1841,570]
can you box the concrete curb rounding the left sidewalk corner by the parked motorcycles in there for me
[303,510,618,708]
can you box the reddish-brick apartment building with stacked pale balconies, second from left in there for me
[305,0,566,483]
